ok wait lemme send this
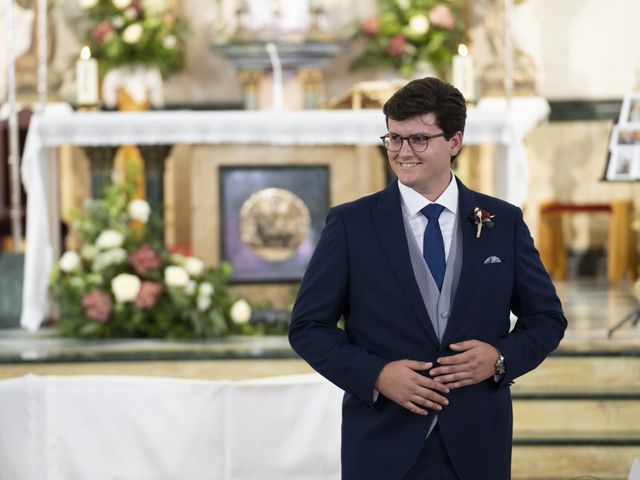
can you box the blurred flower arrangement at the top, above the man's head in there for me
[352,0,463,77]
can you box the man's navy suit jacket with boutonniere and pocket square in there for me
[289,179,566,480]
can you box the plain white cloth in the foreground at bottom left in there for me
[0,374,342,480]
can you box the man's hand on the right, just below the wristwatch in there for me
[429,340,500,388]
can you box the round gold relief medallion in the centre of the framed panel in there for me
[240,188,311,262]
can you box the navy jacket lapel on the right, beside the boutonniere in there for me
[442,178,487,345]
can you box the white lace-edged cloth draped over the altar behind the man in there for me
[20,97,549,330]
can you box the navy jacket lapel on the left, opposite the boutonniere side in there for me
[372,182,438,343]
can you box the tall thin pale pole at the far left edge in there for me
[4,0,22,253]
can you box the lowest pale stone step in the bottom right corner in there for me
[511,439,640,480]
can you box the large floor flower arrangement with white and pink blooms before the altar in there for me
[50,182,245,339]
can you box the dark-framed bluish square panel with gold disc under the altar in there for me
[220,166,330,282]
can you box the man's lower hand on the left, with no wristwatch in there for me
[375,360,449,415]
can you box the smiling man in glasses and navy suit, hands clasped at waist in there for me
[289,78,567,480]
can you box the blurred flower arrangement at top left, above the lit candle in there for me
[80,0,188,76]
